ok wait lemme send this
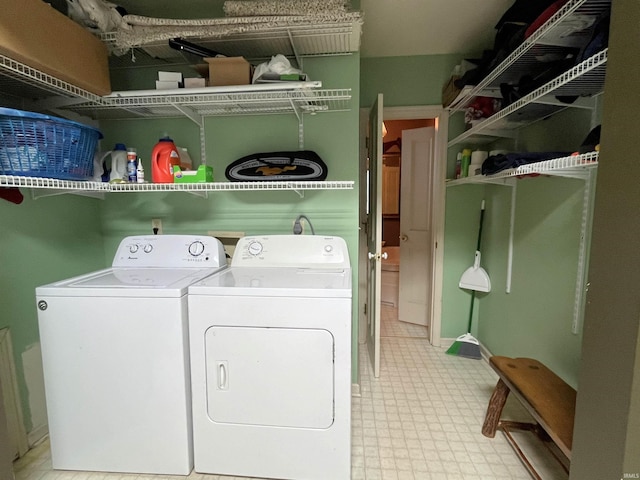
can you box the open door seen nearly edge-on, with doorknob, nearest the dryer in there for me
[367,94,383,377]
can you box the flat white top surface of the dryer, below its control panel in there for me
[189,267,351,298]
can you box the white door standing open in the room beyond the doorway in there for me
[398,127,435,326]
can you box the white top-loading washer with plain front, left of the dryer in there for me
[36,235,227,475]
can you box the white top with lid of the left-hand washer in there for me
[36,267,225,297]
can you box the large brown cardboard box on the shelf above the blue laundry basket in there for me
[0,0,111,95]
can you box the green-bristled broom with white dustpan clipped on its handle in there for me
[446,200,491,360]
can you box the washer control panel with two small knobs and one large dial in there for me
[112,235,227,268]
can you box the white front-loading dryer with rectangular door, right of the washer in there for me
[189,235,351,480]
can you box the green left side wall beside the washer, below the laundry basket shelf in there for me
[0,195,104,431]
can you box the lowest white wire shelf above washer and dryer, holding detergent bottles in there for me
[0,175,354,198]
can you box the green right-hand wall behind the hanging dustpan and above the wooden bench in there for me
[442,110,591,387]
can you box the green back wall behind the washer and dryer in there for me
[101,54,360,380]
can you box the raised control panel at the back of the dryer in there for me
[231,235,350,269]
